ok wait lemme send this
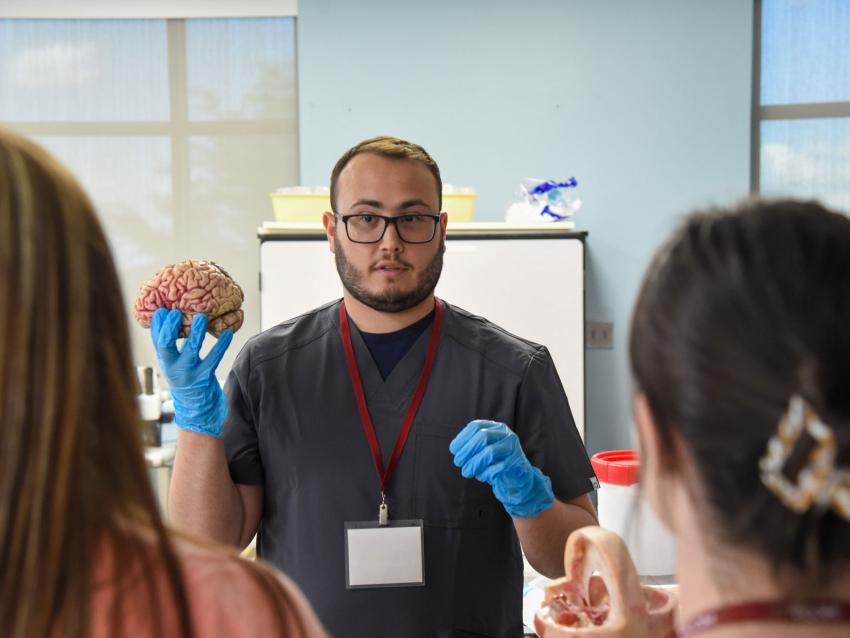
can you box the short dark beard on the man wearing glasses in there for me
[334,238,445,312]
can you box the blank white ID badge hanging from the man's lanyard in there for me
[345,519,425,589]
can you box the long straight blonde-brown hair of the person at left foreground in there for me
[0,130,304,638]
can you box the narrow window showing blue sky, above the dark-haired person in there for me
[752,0,850,213]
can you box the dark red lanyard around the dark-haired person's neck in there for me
[676,600,850,638]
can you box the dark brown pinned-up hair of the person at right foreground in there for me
[629,200,850,584]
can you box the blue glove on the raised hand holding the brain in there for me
[151,308,233,437]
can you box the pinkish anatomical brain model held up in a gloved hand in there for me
[133,260,245,337]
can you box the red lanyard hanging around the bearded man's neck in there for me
[339,298,443,497]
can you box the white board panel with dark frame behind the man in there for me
[260,228,585,438]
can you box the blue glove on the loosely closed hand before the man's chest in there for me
[449,419,555,518]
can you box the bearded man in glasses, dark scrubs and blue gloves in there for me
[159,137,596,638]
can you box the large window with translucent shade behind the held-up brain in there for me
[0,17,298,371]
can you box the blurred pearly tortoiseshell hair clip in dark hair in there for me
[759,394,850,521]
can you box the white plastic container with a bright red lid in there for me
[591,450,676,578]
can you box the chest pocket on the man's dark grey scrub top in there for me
[414,428,500,529]
